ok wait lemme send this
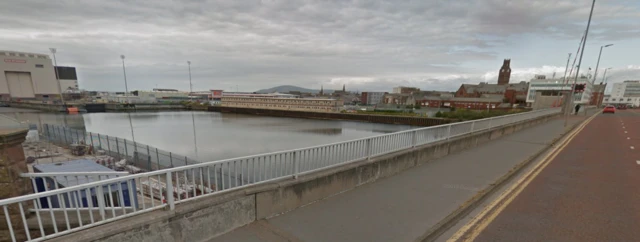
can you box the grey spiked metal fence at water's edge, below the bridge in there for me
[42,124,200,173]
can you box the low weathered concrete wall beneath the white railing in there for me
[52,112,555,242]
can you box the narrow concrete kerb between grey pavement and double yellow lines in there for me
[415,114,586,242]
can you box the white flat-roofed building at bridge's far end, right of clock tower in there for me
[527,76,594,106]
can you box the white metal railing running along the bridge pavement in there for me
[0,108,560,241]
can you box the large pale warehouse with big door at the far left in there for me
[0,50,60,101]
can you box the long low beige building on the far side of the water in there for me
[220,94,344,112]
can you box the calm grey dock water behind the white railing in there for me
[0,108,411,161]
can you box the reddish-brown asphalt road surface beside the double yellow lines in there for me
[474,110,640,242]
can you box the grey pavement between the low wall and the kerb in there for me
[211,110,595,242]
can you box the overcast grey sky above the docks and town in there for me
[0,0,640,91]
